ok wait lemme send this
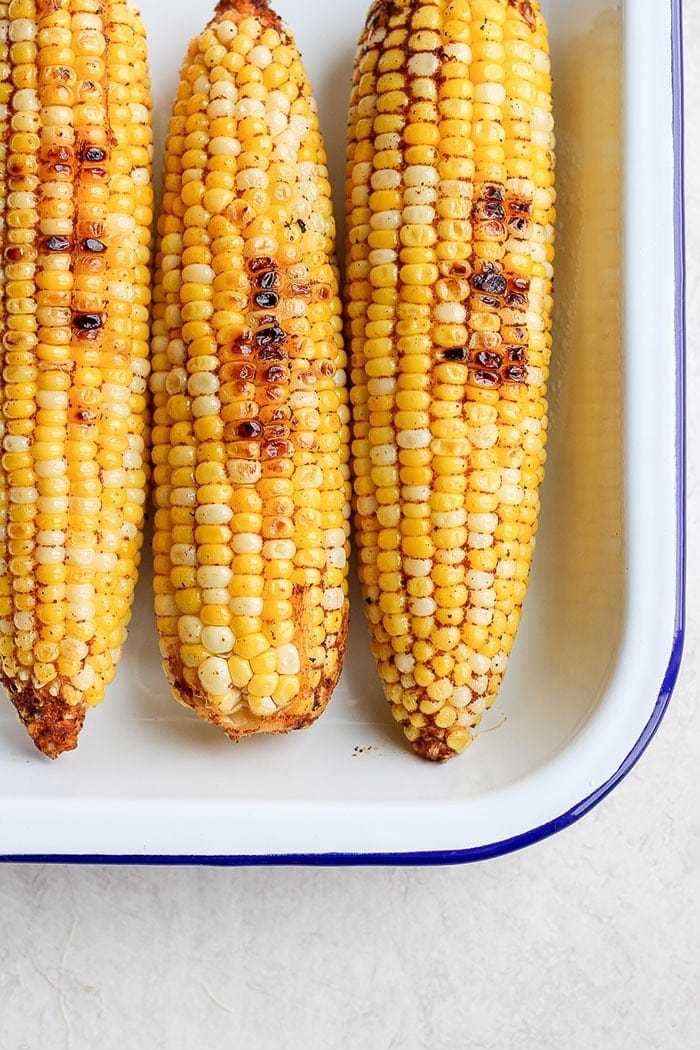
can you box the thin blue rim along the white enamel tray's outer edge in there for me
[0,0,686,867]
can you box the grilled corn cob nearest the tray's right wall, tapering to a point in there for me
[347,0,554,760]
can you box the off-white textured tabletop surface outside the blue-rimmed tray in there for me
[0,0,700,1050]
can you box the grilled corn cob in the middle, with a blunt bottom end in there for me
[151,0,349,740]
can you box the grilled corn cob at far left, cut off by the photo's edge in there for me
[0,0,152,757]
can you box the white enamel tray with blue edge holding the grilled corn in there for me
[0,0,684,864]
